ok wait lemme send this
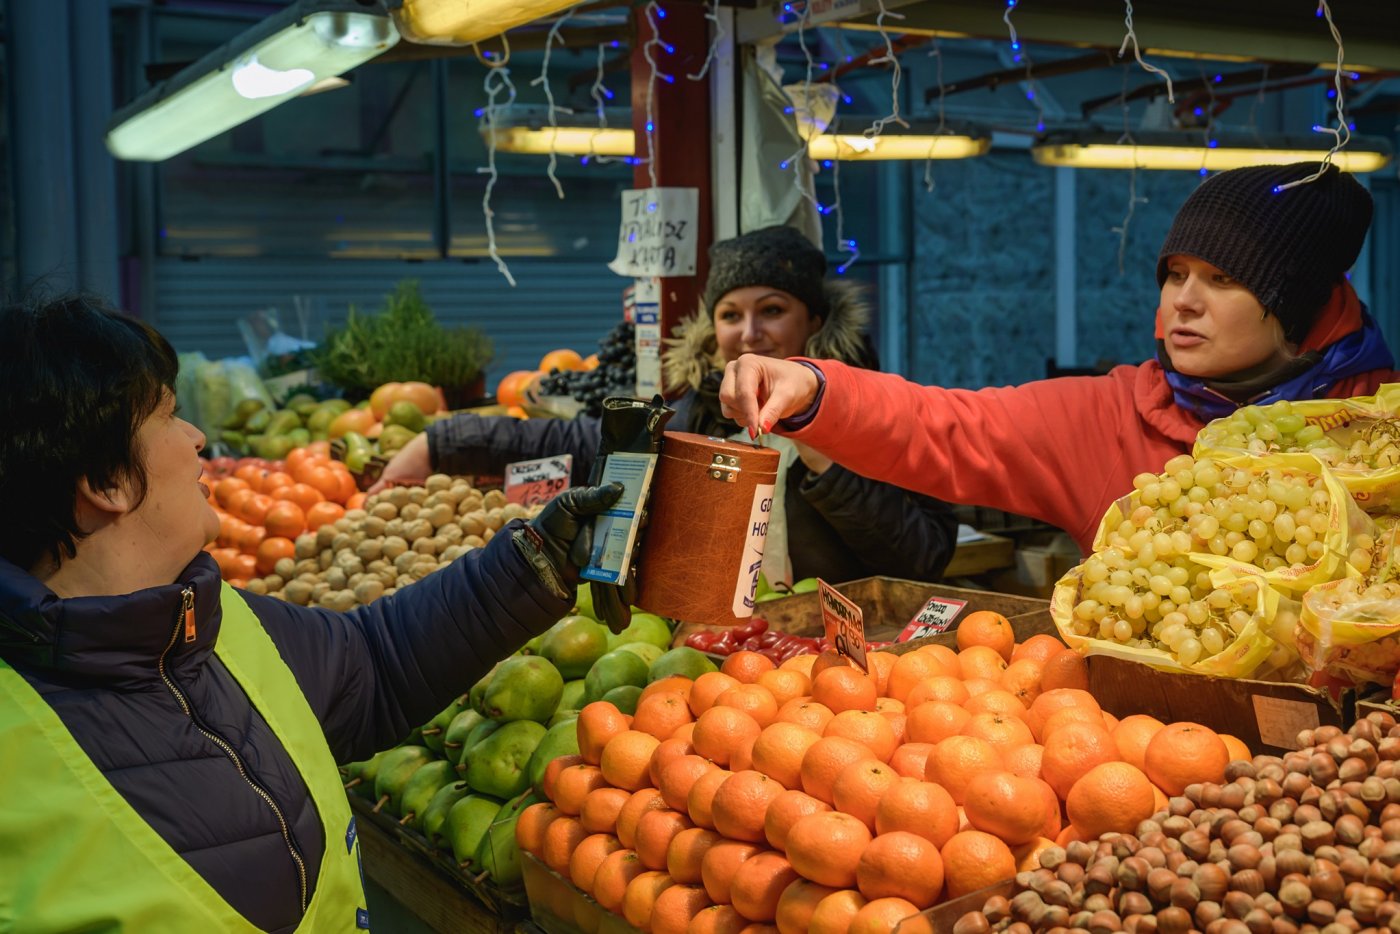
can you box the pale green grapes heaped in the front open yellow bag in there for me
[1071,454,1331,667]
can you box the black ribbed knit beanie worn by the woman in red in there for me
[1156,162,1372,343]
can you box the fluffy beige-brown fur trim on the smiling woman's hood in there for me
[661,279,871,391]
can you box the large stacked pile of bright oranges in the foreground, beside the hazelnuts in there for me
[517,612,1249,934]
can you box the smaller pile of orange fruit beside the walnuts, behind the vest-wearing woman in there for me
[203,441,364,587]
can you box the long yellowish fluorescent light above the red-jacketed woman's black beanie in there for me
[1030,130,1390,172]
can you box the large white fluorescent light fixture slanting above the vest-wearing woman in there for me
[106,0,399,162]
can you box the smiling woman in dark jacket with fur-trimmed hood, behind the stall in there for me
[384,227,958,584]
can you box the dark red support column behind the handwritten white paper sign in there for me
[631,4,714,394]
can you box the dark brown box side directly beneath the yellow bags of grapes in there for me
[1088,655,1357,753]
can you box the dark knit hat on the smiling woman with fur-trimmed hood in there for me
[703,225,826,318]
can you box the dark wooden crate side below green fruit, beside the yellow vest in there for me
[350,795,528,934]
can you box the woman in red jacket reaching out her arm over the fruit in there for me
[720,162,1396,552]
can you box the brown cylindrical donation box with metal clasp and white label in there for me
[637,431,780,626]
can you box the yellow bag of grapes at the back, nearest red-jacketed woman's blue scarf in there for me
[1194,384,1400,515]
